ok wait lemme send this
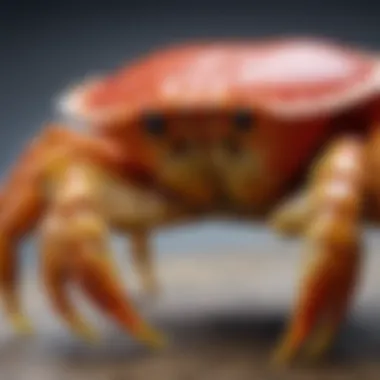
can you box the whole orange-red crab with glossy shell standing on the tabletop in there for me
[0,37,380,364]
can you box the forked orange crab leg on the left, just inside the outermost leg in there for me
[44,161,164,346]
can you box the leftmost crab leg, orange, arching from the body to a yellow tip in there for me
[0,126,119,332]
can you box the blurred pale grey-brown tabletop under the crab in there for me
[0,235,380,380]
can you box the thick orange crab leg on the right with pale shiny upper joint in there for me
[274,137,366,364]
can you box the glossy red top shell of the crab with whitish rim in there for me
[61,38,380,125]
